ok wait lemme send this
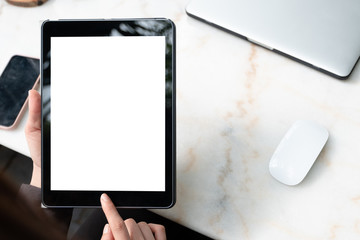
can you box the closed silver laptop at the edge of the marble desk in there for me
[186,0,360,79]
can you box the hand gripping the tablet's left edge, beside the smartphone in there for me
[25,90,41,188]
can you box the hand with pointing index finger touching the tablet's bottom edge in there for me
[100,193,166,240]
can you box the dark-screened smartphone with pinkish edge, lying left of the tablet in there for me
[0,55,40,129]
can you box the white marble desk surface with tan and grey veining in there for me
[0,0,360,239]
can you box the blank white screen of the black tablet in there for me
[50,36,165,191]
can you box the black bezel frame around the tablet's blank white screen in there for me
[41,18,176,208]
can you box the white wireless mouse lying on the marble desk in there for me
[269,120,329,186]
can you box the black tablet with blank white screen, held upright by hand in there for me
[41,19,176,208]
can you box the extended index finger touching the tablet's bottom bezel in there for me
[100,193,130,240]
